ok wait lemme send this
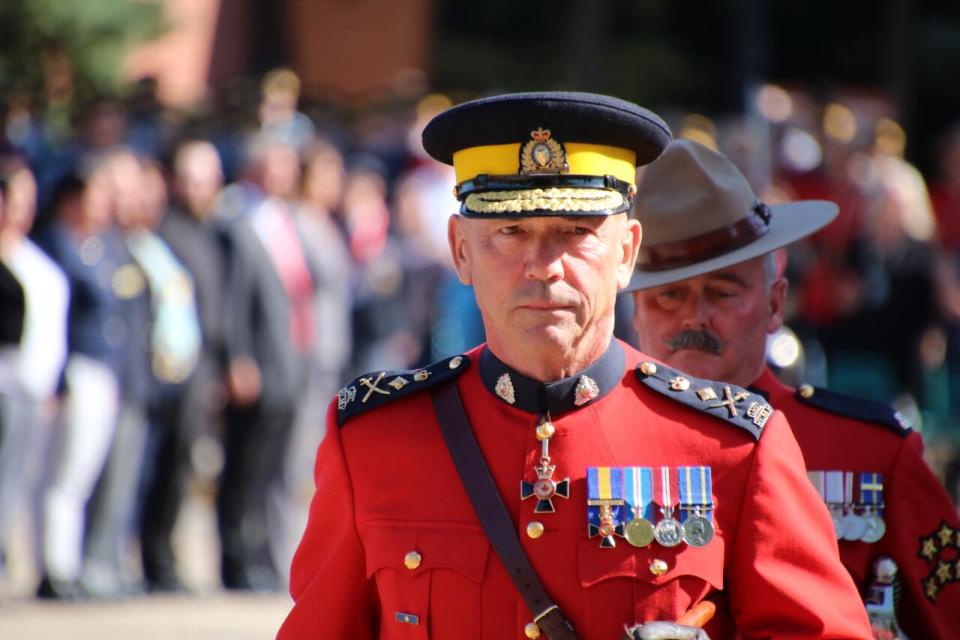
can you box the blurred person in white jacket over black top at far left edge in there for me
[0,151,70,575]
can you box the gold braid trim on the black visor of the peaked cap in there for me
[465,188,624,213]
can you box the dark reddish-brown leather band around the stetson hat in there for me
[637,202,773,271]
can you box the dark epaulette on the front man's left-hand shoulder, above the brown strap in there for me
[337,355,470,426]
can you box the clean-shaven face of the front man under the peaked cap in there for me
[449,215,640,370]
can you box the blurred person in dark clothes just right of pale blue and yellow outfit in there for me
[155,139,233,590]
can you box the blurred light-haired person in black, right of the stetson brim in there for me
[818,156,939,410]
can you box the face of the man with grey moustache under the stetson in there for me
[633,257,787,386]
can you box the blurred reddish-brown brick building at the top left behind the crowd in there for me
[124,0,432,106]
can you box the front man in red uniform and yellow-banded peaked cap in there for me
[279,93,869,640]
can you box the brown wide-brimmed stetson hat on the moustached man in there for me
[624,140,838,292]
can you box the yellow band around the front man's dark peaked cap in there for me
[453,142,637,184]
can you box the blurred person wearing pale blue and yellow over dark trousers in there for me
[126,159,202,591]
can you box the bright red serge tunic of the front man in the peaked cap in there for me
[278,341,870,640]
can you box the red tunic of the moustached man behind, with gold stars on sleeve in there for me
[754,370,960,640]
